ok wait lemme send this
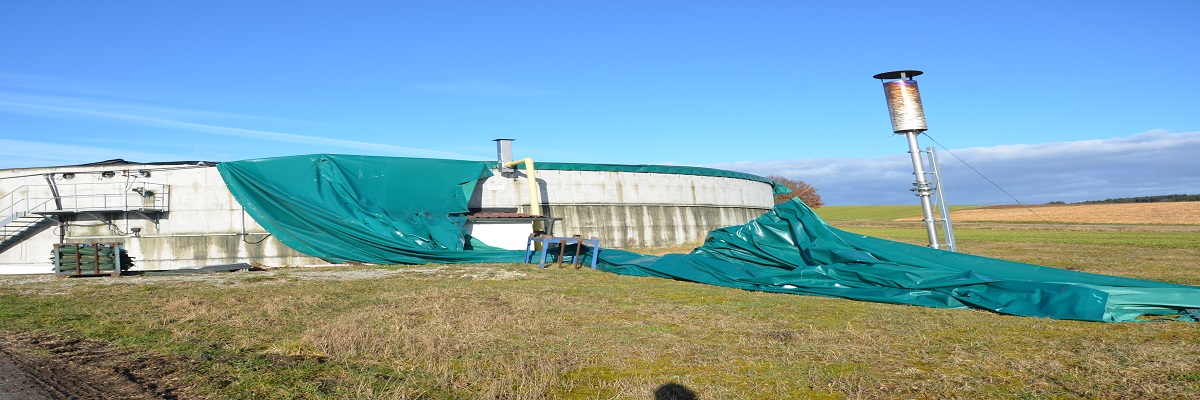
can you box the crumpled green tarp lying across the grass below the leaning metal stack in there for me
[599,199,1200,322]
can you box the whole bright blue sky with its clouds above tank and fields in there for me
[0,0,1200,204]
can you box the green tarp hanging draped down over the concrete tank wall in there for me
[217,154,524,264]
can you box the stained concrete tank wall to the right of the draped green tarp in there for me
[470,169,774,247]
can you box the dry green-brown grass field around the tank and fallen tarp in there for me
[0,204,1200,399]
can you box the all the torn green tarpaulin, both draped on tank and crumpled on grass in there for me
[217,155,1200,322]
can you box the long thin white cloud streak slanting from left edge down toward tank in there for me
[0,91,486,160]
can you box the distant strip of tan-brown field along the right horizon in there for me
[896,202,1200,225]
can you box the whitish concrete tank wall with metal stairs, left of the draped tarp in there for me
[0,160,324,274]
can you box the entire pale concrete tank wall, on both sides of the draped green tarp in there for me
[0,157,773,274]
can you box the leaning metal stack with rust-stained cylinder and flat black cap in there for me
[874,70,940,249]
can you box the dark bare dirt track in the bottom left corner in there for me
[0,330,180,400]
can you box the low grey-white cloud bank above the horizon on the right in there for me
[712,131,1200,204]
